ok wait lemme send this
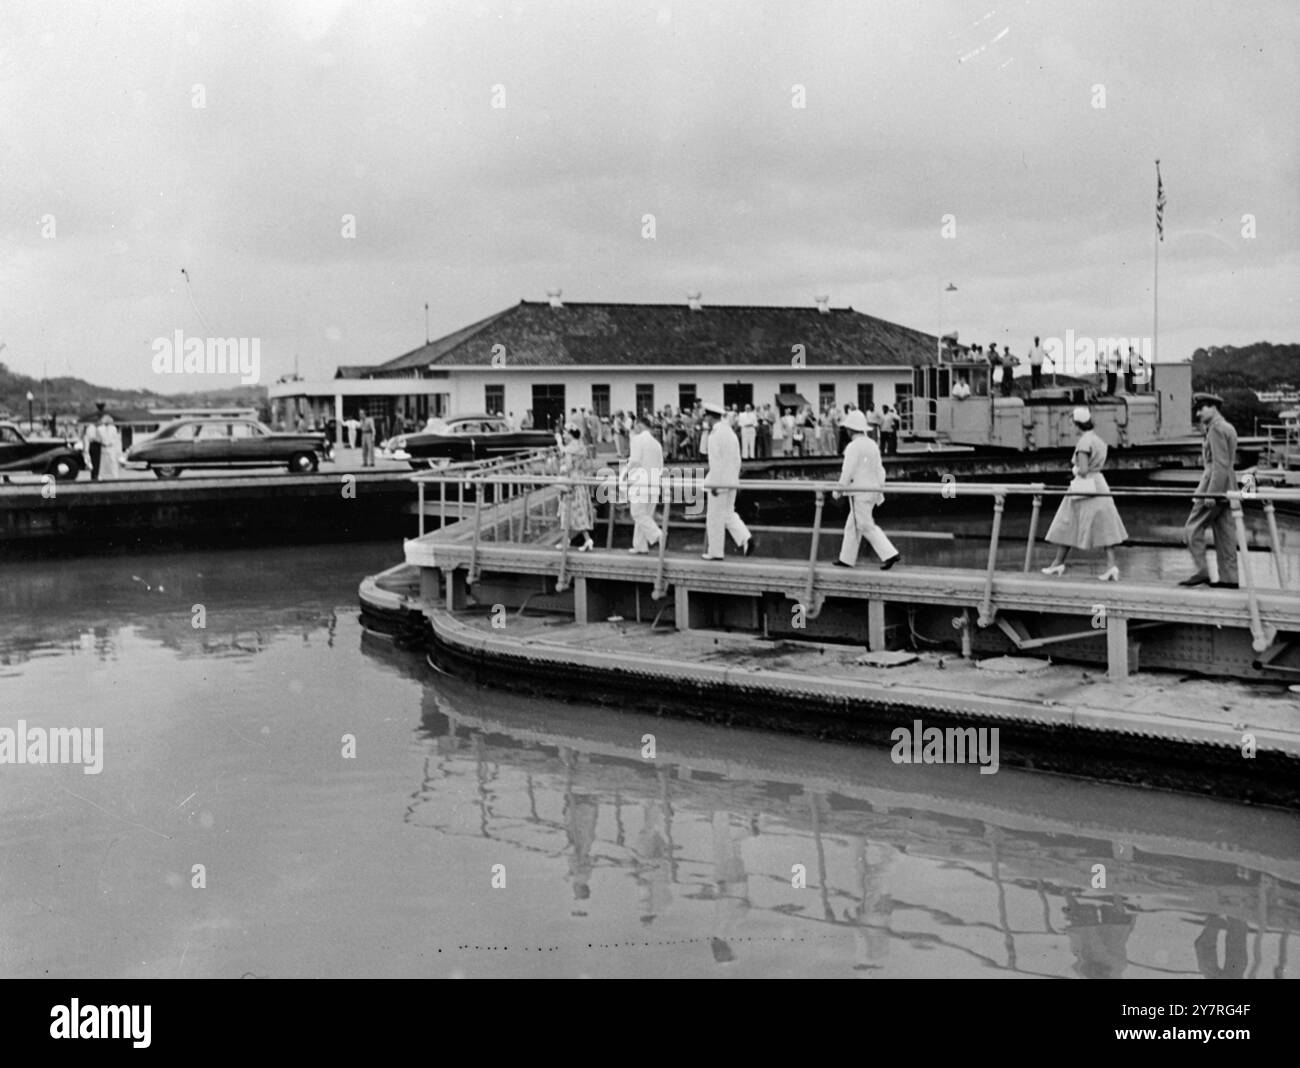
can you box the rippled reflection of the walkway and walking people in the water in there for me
[407,678,1300,978]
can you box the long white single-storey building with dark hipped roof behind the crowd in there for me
[270,298,937,433]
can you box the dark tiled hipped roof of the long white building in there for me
[356,300,937,377]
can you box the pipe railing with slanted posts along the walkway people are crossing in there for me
[413,465,1300,652]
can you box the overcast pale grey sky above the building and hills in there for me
[0,0,1300,391]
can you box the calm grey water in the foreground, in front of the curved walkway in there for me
[0,543,1300,978]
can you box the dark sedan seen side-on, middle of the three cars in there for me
[126,417,334,478]
